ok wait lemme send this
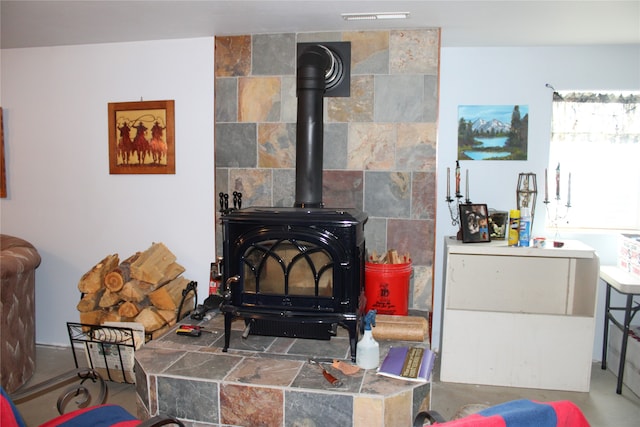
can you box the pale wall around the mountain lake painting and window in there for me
[433,45,640,360]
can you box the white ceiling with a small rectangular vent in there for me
[0,0,640,49]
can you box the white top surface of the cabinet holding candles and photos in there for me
[445,236,595,258]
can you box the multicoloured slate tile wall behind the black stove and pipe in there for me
[215,29,440,311]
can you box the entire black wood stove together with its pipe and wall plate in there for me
[221,42,367,361]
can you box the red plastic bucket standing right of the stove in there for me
[364,262,411,316]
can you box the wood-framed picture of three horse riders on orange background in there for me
[109,101,176,174]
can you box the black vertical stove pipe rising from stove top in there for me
[294,45,335,208]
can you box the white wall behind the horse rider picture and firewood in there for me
[0,38,215,345]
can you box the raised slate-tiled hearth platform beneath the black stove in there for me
[136,315,431,427]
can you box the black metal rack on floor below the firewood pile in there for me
[67,322,149,384]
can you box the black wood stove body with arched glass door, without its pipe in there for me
[221,208,366,358]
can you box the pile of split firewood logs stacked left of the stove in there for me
[77,243,195,337]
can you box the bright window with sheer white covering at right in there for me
[547,92,640,230]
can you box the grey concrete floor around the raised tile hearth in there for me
[10,346,640,427]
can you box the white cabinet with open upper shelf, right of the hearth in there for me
[440,238,599,391]
